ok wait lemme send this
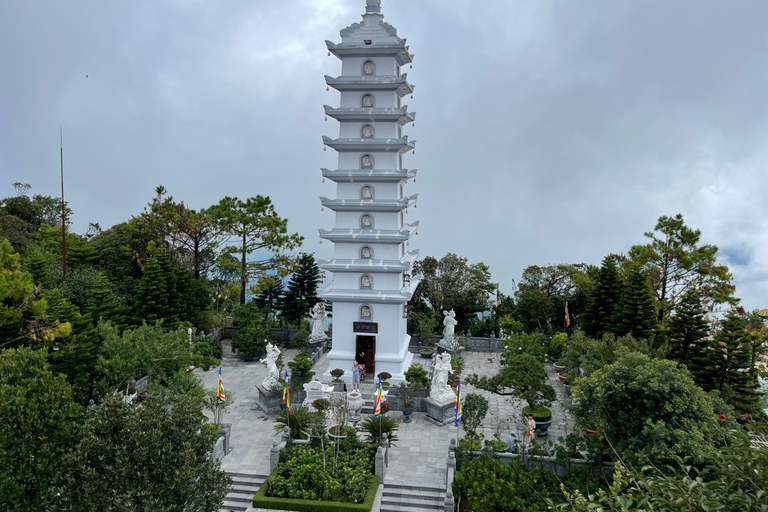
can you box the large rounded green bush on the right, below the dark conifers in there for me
[571,353,724,467]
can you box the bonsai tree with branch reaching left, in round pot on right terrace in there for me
[467,352,556,422]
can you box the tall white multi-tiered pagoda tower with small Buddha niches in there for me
[318,0,418,382]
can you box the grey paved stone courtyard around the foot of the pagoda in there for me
[195,341,572,487]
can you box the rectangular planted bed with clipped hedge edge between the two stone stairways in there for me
[263,442,376,503]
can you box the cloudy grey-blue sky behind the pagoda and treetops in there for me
[0,0,768,309]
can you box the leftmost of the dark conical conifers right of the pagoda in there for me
[582,255,623,337]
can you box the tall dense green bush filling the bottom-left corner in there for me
[0,348,85,511]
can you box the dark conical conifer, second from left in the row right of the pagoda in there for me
[611,265,658,340]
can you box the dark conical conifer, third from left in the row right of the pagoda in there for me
[669,288,709,364]
